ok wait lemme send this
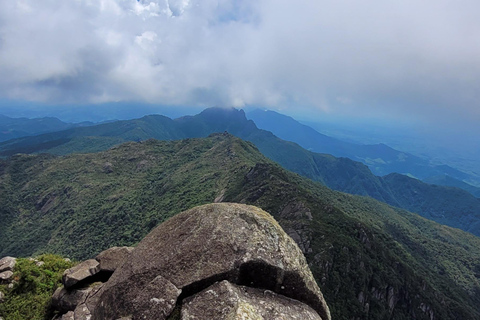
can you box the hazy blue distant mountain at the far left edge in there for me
[0,114,93,142]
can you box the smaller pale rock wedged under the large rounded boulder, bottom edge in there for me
[182,281,321,320]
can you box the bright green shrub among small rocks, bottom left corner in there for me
[0,254,73,320]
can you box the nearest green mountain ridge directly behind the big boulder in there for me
[0,133,480,319]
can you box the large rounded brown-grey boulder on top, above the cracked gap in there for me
[87,203,330,320]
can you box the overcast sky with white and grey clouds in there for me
[0,0,480,130]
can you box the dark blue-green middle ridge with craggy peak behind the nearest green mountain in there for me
[0,108,480,235]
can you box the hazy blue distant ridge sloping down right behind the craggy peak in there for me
[247,109,472,186]
